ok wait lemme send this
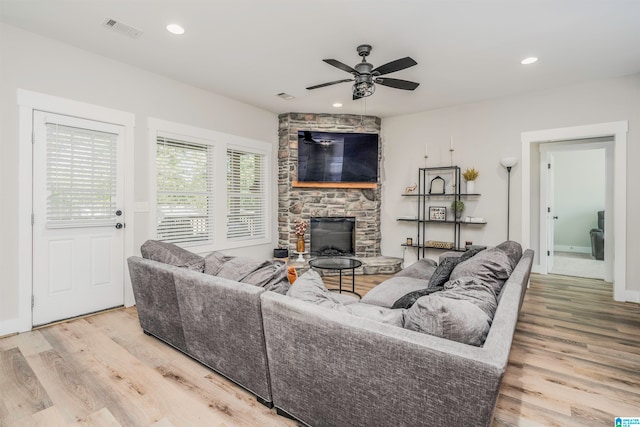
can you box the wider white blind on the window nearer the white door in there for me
[156,137,214,246]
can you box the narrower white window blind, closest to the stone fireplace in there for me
[227,149,267,240]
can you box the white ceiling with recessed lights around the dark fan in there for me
[0,0,640,117]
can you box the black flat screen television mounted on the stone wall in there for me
[298,131,378,182]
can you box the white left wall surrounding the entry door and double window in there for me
[0,24,278,330]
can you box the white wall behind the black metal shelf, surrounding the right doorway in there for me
[381,74,640,290]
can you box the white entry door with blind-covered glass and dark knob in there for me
[32,111,124,326]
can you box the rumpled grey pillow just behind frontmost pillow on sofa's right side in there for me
[450,246,513,295]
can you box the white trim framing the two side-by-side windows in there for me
[148,117,273,254]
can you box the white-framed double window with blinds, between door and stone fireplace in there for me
[149,119,273,254]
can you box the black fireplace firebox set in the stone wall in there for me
[310,217,356,257]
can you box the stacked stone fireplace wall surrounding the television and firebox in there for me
[278,113,382,258]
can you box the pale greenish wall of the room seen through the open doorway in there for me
[553,148,605,253]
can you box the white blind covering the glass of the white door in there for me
[46,123,118,228]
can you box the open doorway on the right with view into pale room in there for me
[540,138,613,280]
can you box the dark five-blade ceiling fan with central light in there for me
[307,44,420,100]
